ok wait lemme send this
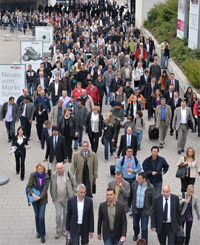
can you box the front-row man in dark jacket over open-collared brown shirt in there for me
[97,188,127,244]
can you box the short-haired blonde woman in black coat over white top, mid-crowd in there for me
[84,106,103,153]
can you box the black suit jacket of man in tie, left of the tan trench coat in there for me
[45,135,67,163]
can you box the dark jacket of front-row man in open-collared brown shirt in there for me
[97,202,127,241]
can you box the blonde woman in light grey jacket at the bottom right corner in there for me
[179,185,200,245]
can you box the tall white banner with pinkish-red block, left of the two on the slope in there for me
[177,0,188,39]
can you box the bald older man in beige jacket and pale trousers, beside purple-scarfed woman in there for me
[50,163,77,239]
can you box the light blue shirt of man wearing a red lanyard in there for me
[115,157,142,179]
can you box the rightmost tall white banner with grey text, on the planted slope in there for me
[188,0,200,49]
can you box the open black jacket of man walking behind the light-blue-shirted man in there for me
[117,134,138,157]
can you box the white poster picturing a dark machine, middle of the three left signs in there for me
[20,41,43,72]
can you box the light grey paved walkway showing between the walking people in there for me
[0,27,200,245]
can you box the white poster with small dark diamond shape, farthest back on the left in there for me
[35,26,53,57]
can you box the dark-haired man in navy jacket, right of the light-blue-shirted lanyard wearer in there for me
[142,146,169,196]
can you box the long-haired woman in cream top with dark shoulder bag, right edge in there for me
[177,147,200,192]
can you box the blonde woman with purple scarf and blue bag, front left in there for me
[27,162,49,243]
